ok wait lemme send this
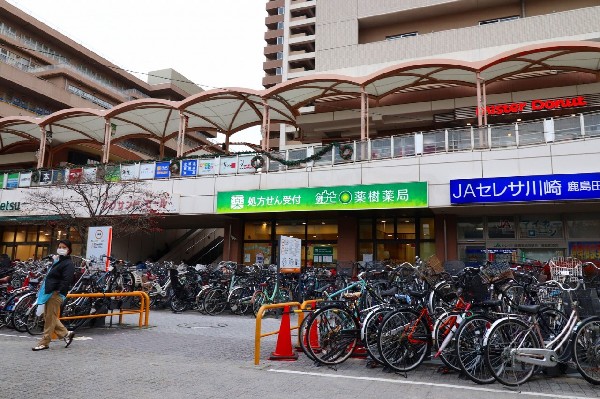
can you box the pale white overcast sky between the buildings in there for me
[8,0,267,144]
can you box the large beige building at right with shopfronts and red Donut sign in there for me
[0,0,600,266]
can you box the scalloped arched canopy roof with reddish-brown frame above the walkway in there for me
[0,42,600,153]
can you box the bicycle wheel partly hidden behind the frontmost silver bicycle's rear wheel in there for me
[455,315,496,384]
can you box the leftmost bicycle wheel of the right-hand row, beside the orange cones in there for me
[307,306,360,365]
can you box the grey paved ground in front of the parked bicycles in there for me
[0,311,600,399]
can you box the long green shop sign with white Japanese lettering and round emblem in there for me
[217,182,428,213]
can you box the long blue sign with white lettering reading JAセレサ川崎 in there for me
[450,173,600,204]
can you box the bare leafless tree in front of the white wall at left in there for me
[22,170,169,245]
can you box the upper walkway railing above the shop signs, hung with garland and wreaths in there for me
[0,112,600,189]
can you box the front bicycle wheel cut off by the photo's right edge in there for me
[573,317,600,385]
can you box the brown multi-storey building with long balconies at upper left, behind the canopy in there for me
[0,0,206,169]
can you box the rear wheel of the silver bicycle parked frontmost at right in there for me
[484,318,541,386]
